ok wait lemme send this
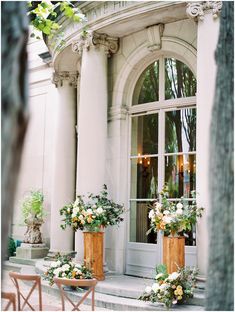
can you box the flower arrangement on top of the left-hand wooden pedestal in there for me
[60,185,124,232]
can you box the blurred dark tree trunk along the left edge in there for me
[1,1,28,260]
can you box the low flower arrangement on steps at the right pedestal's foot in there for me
[139,264,198,308]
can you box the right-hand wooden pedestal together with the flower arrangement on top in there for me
[147,185,203,273]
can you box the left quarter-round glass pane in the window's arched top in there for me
[133,61,159,105]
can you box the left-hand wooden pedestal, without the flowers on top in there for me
[83,232,105,281]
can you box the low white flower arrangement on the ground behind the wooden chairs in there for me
[44,254,93,285]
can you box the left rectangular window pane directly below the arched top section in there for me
[131,114,158,156]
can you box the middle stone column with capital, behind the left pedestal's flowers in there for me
[72,33,118,260]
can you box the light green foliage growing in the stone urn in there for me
[21,191,45,221]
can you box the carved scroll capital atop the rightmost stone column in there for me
[186,1,222,21]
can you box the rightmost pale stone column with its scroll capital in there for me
[187,1,222,276]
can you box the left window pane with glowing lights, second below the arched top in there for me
[131,157,158,199]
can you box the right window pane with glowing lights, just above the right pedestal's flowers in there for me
[165,155,196,198]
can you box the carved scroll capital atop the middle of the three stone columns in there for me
[72,32,119,56]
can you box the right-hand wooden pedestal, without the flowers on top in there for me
[163,236,185,273]
